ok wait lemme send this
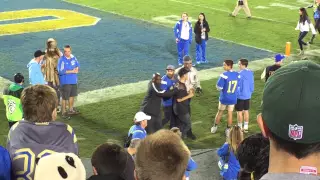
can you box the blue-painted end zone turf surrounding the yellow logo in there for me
[0,0,272,92]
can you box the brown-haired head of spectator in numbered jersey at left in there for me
[21,85,58,123]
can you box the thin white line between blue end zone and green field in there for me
[62,0,274,53]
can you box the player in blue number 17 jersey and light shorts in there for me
[211,60,240,134]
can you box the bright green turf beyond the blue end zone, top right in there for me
[67,0,318,52]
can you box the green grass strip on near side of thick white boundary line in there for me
[0,53,320,157]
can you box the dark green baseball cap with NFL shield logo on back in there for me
[262,61,320,144]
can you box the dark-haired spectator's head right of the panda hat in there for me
[91,143,134,179]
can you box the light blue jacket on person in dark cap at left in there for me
[27,59,46,85]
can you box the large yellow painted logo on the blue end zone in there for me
[0,9,100,36]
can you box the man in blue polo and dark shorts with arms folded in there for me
[57,45,80,119]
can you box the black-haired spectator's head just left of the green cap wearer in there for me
[237,133,269,179]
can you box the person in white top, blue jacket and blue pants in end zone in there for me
[173,12,192,66]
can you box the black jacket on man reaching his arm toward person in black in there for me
[140,82,173,116]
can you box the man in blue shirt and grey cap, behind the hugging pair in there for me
[160,65,177,128]
